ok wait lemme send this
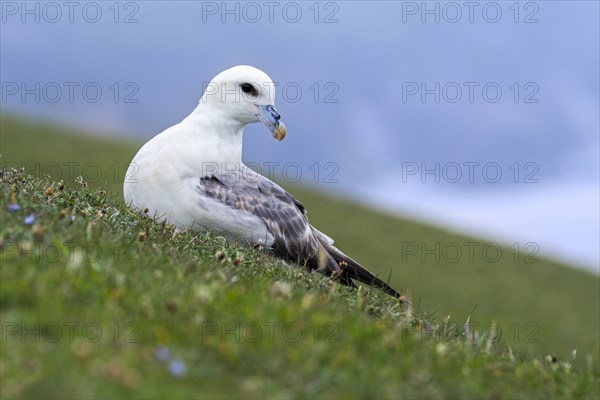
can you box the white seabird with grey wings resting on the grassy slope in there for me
[123,65,401,298]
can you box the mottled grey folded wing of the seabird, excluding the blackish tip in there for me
[197,174,339,275]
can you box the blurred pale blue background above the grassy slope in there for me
[0,1,600,272]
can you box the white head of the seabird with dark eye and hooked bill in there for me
[199,65,286,140]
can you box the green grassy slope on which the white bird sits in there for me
[0,115,600,398]
